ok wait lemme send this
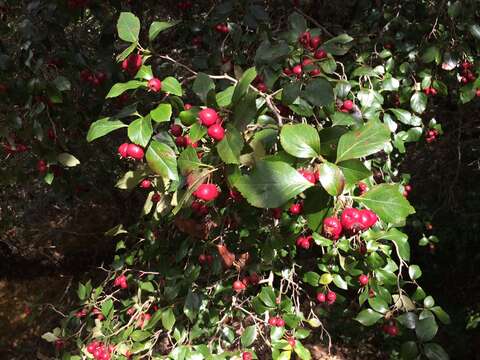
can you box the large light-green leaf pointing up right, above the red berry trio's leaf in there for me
[337,120,390,163]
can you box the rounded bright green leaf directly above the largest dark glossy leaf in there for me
[280,124,320,159]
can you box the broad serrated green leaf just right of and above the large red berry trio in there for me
[354,184,415,225]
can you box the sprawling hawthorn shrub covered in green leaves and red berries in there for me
[1,1,480,360]
